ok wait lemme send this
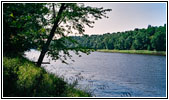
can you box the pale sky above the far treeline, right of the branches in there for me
[85,2,166,35]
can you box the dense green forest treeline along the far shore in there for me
[68,24,166,51]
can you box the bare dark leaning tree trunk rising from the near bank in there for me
[37,3,66,66]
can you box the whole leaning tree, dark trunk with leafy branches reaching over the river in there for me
[37,3,111,66]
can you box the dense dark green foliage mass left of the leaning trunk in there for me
[3,3,49,53]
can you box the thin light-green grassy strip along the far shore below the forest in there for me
[97,49,166,56]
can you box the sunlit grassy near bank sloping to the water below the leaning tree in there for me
[3,56,91,97]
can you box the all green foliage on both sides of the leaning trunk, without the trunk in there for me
[3,3,111,64]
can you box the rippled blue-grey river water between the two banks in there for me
[25,50,166,97]
